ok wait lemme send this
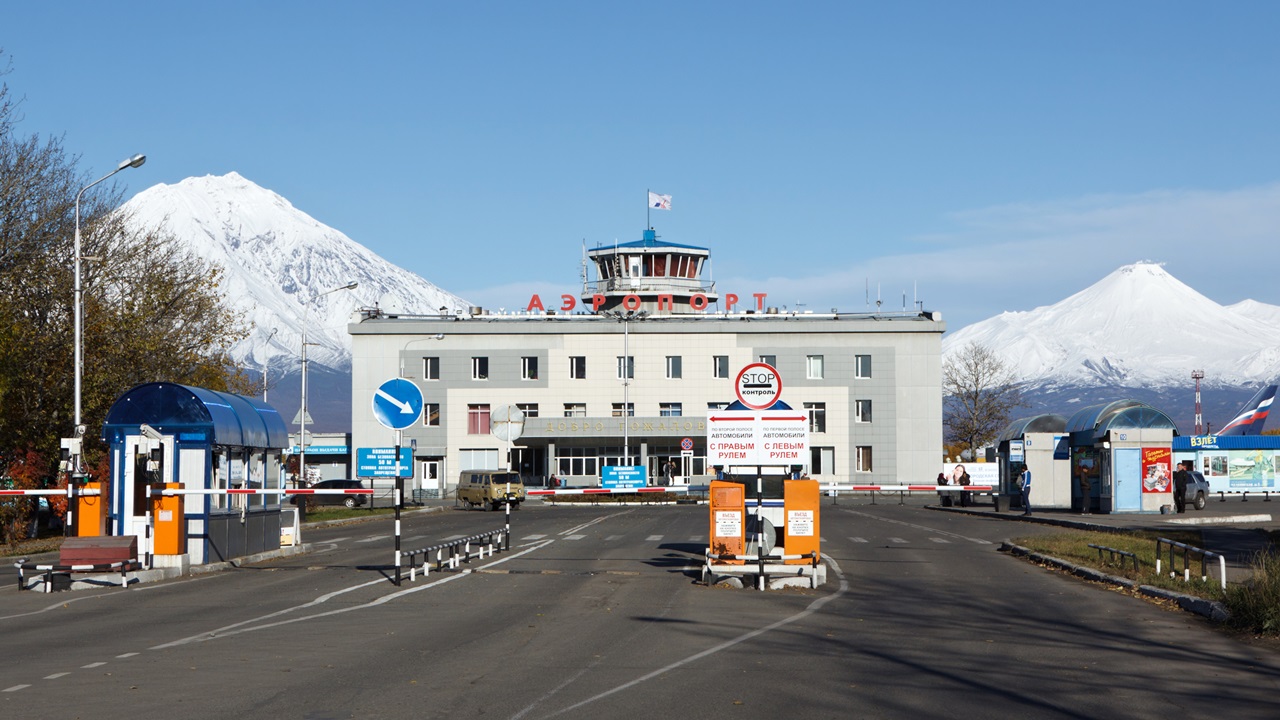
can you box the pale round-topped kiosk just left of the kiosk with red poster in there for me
[996,414,1075,510]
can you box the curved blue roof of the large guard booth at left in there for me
[102,383,289,448]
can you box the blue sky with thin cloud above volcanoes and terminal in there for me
[0,0,1280,329]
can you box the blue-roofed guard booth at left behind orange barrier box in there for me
[102,383,288,565]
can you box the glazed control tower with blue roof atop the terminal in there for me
[582,228,719,315]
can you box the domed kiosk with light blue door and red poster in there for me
[1059,400,1178,512]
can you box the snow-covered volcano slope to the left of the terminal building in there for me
[124,173,470,369]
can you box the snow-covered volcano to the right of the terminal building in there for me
[942,263,1280,388]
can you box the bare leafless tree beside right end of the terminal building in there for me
[942,343,1025,452]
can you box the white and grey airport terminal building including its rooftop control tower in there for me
[348,229,945,493]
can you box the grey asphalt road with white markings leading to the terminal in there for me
[0,501,1280,720]
